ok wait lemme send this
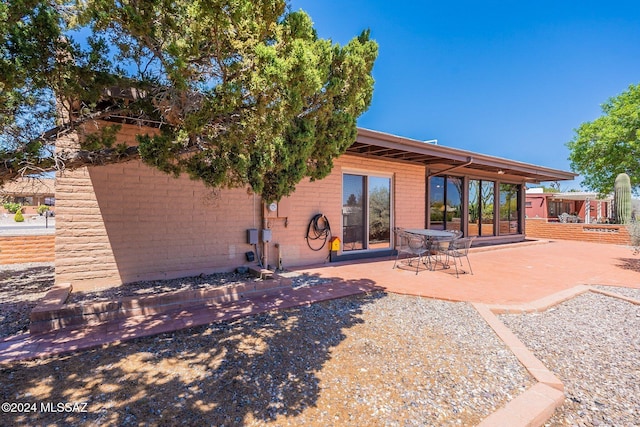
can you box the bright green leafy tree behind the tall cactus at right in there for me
[567,85,640,194]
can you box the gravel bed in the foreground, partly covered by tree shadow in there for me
[0,266,533,426]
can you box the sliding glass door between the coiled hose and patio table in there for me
[342,174,391,251]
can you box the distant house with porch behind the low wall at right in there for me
[525,188,612,224]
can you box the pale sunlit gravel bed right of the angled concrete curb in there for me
[500,287,640,426]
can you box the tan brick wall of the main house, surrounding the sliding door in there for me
[55,126,425,290]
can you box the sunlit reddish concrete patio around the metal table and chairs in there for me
[300,240,640,305]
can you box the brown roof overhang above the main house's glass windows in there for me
[347,128,577,183]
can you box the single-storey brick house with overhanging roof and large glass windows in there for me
[55,121,575,290]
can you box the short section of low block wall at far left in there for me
[0,234,55,265]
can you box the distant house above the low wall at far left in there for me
[0,178,55,213]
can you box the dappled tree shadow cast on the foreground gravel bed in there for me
[0,282,384,426]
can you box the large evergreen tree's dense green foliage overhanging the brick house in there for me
[0,0,377,201]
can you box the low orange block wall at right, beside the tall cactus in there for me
[526,218,631,245]
